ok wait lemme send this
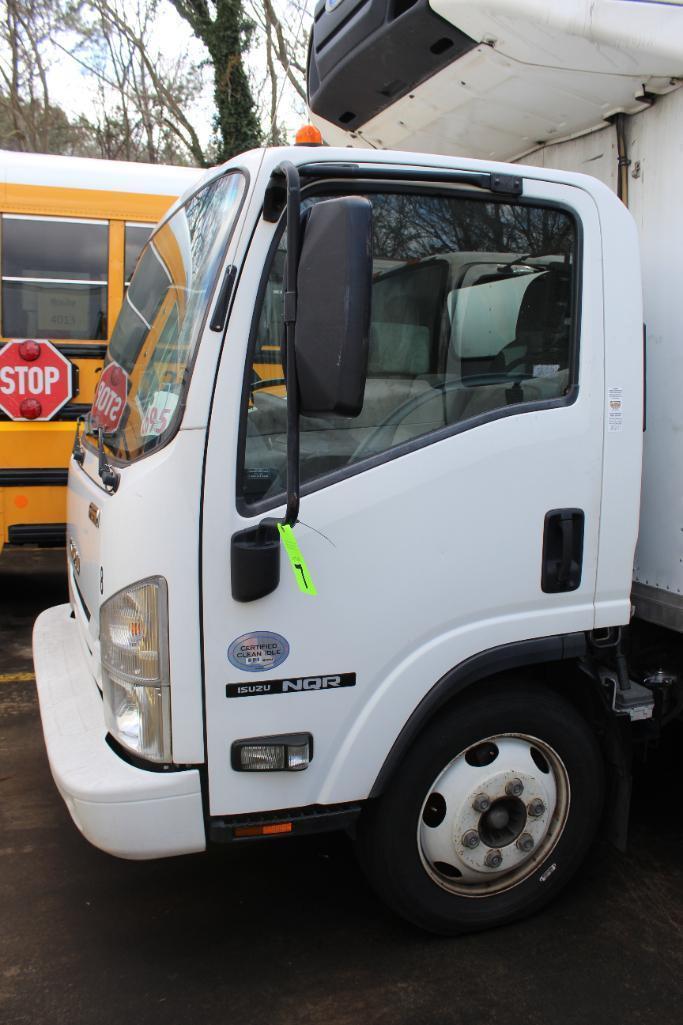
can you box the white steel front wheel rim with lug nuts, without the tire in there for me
[417,733,570,897]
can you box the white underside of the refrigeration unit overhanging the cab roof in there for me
[313,0,683,160]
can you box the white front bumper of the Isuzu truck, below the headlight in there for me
[33,605,206,858]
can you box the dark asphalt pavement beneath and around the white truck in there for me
[0,551,683,1025]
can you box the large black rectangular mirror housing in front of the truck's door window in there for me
[295,196,372,416]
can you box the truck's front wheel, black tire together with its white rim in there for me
[357,681,604,935]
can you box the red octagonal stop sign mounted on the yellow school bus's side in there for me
[0,338,74,420]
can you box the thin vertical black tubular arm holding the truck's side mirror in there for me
[279,160,302,527]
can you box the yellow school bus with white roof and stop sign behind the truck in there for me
[0,151,202,548]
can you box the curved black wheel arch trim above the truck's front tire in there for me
[369,633,587,797]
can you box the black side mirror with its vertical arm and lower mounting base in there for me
[231,172,372,602]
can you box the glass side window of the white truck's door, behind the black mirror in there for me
[241,193,577,503]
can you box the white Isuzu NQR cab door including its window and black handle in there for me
[201,174,603,815]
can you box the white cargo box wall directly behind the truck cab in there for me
[524,89,683,630]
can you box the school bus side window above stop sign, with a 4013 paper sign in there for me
[2,214,109,339]
